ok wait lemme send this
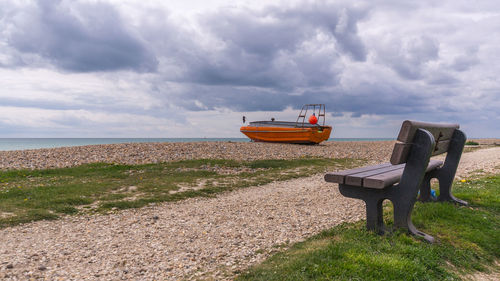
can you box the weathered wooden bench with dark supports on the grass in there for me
[325,120,467,243]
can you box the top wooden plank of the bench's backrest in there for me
[398,120,460,143]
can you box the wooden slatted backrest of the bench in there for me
[391,120,459,165]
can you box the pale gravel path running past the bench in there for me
[0,142,500,280]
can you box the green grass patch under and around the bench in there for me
[238,175,500,280]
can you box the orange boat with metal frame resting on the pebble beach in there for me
[240,104,332,144]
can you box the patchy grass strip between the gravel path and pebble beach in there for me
[0,158,363,227]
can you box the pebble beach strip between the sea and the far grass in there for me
[0,141,394,170]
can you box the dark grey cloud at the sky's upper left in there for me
[3,0,157,72]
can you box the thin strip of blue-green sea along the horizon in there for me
[0,138,394,151]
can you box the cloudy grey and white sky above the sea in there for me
[0,0,500,138]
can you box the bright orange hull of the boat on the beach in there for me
[240,126,332,144]
